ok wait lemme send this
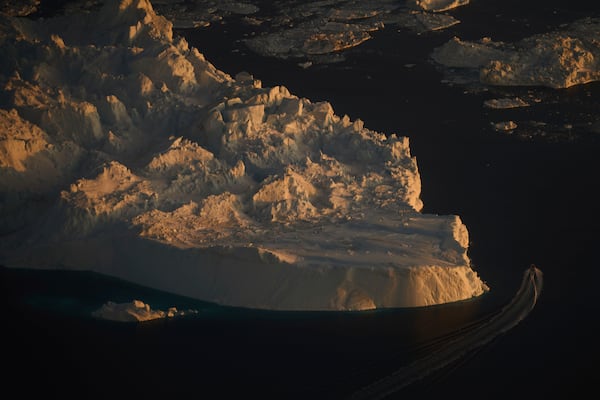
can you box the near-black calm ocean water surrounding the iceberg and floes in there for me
[0,0,600,399]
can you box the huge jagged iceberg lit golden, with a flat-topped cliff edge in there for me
[0,0,488,310]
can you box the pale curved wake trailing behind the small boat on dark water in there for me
[350,265,543,400]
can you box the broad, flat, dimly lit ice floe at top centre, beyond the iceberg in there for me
[244,0,467,63]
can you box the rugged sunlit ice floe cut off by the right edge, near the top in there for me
[431,18,600,89]
